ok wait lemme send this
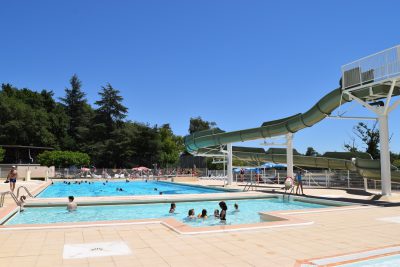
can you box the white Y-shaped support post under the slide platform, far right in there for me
[343,79,400,196]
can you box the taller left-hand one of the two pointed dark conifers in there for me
[61,74,92,149]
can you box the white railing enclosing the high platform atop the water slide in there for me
[342,45,400,90]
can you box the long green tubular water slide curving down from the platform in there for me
[184,85,400,180]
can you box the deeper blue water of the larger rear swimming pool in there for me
[38,181,226,198]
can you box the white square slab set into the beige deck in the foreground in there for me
[63,241,132,259]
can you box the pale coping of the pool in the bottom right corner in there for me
[294,244,400,267]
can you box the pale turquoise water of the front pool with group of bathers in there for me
[7,198,327,226]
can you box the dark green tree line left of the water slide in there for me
[0,75,184,168]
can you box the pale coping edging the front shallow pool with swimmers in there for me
[0,195,374,235]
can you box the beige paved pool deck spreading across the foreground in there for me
[0,181,400,267]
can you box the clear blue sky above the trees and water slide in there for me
[0,0,400,152]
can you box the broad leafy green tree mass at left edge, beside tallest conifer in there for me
[0,84,67,148]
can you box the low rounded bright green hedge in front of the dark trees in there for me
[37,150,90,167]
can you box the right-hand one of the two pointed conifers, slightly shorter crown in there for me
[95,83,128,132]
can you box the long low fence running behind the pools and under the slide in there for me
[41,168,400,193]
